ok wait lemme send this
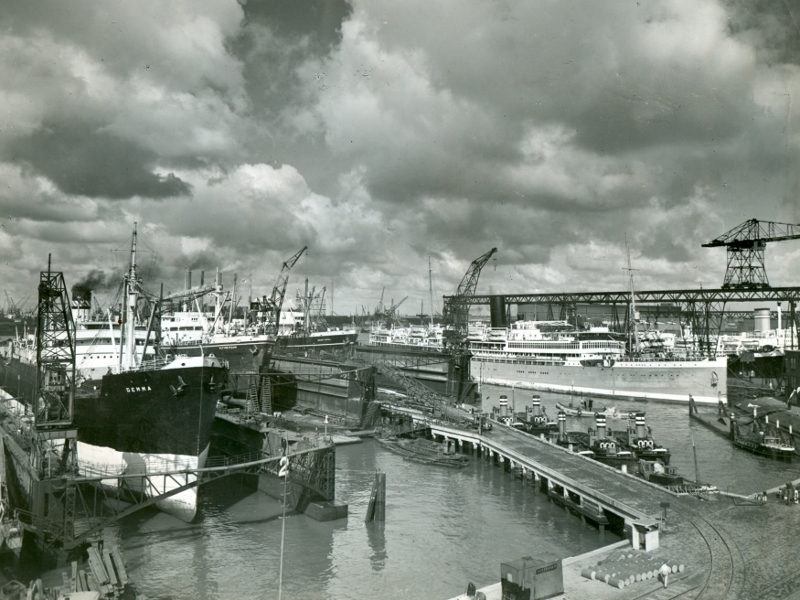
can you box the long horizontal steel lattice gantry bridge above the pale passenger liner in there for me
[444,287,800,356]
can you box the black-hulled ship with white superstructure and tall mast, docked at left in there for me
[0,228,228,521]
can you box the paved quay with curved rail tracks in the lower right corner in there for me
[438,428,800,600]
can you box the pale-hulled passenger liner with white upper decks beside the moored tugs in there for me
[470,321,727,404]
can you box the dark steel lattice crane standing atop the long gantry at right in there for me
[703,219,800,289]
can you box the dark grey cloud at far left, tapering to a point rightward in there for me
[4,122,191,199]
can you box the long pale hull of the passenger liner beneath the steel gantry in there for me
[470,356,728,404]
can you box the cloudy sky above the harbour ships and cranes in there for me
[0,0,800,314]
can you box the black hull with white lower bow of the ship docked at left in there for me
[0,357,227,522]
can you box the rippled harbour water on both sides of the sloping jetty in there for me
[103,386,799,600]
